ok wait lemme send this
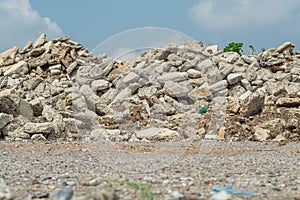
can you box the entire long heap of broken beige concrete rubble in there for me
[0,34,300,142]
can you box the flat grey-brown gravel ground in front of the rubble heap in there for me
[0,140,300,200]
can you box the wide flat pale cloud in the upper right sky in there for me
[188,0,300,30]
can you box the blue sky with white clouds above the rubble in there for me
[0,0,300,52]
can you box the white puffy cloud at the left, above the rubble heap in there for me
[0,0,63,50]
